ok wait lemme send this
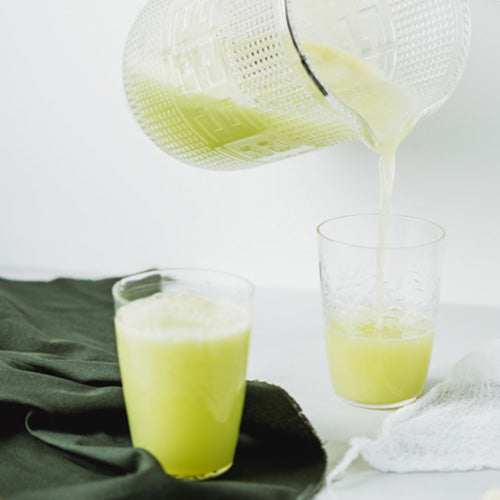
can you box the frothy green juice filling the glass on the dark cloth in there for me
[115,293,250,479]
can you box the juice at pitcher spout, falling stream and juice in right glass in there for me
[304,45,434,406]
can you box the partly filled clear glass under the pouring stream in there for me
[317,214,445,408]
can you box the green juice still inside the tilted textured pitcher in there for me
[127,43,416,167]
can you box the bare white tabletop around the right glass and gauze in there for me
[248,288,500,500]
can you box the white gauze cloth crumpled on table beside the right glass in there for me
[328,339,500,482]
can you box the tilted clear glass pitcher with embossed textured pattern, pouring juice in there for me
[124,0,470,170]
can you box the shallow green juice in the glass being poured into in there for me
[325,313,434,407]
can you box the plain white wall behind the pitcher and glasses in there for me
[0,0,500,306]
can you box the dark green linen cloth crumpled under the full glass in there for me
[0,279,326,500]
